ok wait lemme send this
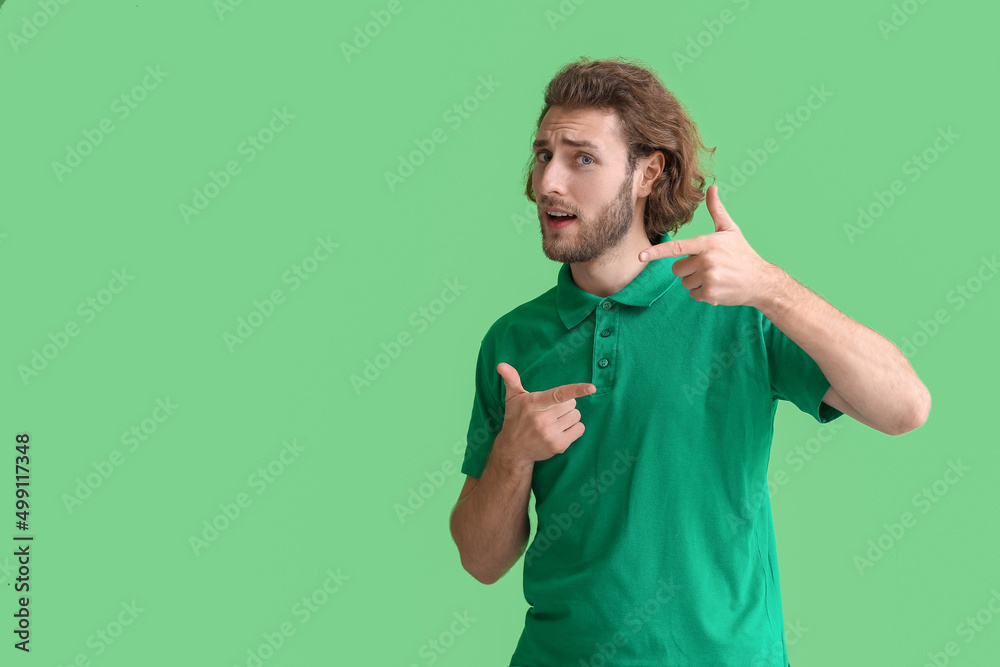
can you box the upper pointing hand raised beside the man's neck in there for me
[639,185,777,306]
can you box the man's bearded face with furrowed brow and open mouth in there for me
[531,106,636,263]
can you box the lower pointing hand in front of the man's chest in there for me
[494,362,597,466]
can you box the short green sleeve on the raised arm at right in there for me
[761,314,844,424]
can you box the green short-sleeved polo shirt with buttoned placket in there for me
[462,228,843,667]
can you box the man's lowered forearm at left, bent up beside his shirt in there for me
[451,436,534,584]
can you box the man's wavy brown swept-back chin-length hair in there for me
[525,57,715,244]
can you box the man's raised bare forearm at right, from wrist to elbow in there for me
[753,265,930,433]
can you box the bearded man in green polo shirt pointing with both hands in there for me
[451,58,930,667]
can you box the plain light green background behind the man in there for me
[0,0,1000,667]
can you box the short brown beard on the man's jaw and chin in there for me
[541,164,635,264]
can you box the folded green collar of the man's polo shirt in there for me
[556,232,680,329]
